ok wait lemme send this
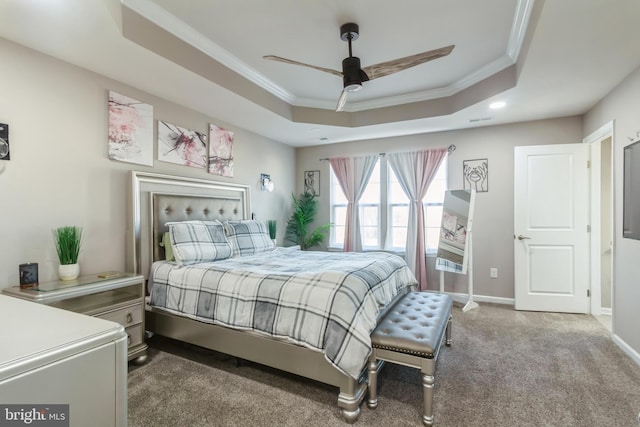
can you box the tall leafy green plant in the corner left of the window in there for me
[285,193,331,250]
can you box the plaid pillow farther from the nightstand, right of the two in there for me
[224,220,274,257]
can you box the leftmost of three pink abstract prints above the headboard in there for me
[109,91,153,166]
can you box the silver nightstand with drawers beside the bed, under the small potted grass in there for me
[2,273,147,363]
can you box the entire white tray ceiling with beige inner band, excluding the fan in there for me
[0,0,640,146]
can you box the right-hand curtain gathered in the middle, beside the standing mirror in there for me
[387,148,447,290]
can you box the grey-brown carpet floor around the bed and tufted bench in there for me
[128,304,640,427]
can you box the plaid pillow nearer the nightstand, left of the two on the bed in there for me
[166,221,231,265]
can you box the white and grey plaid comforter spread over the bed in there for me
[150,248,417,378]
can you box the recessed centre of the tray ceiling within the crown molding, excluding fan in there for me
[145,0,520,110]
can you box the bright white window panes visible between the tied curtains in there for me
[330,157,447,254]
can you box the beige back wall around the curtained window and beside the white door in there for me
[296,117,582,302]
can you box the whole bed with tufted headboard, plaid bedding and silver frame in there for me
[127,171,417,423]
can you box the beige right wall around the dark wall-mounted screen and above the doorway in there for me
[584,69,640,363]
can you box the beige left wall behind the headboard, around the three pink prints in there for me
[0,39,295,288]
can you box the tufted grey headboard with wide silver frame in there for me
[126,171,251,277]
